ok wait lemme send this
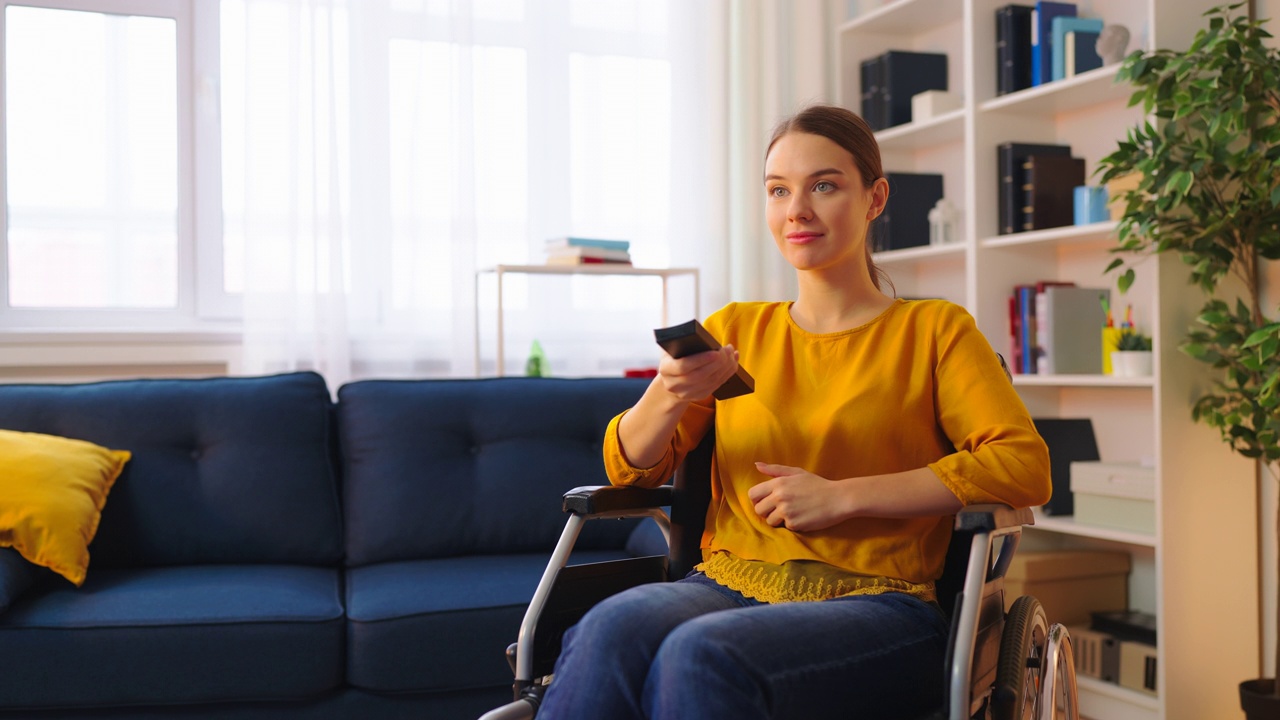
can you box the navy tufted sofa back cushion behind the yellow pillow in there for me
[0,373,342,568]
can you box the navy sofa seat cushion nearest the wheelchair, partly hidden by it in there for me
[347,551,627,692]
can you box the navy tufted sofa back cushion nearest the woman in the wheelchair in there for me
[338,378,648,566]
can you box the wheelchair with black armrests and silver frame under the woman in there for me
[480,432,1079,720]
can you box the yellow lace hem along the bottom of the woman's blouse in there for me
[695,551,937,603]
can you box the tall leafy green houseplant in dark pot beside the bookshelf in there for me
[1098,3,1280,717]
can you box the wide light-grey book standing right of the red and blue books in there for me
[1042,286,1111,375]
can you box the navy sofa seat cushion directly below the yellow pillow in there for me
[0,565,344,707]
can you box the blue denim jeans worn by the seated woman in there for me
[538,573,948,720]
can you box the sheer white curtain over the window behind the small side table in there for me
[220,0,730,387]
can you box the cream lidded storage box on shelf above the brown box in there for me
[1071,462,1156,536]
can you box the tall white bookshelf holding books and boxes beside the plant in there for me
[835,0,1260,720]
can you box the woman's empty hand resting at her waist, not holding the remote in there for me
[746,462,846,533]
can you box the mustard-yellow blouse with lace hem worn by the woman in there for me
[604,300,1050,602]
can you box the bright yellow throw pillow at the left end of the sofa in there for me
[0,430,131,585]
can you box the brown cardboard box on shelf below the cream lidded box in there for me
[1005,550,1129,626]
